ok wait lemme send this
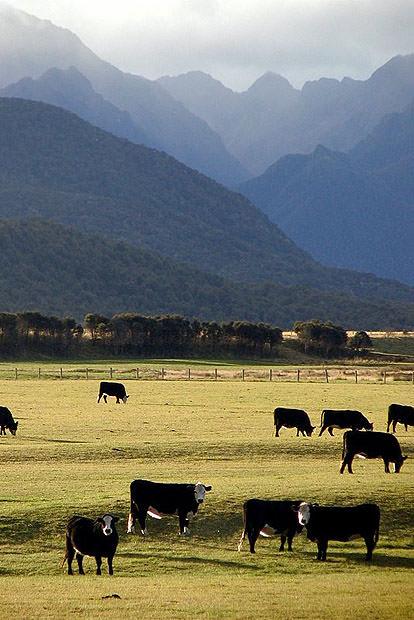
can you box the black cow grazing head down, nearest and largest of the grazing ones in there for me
[339,431,407,474]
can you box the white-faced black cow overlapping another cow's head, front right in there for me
[297,502,380,562]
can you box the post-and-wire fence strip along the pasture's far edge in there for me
[0,366,414,384]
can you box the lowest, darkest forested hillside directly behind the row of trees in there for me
[0,219,414,329]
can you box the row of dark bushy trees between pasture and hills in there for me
[0,312,371,359]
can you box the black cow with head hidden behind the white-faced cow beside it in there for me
[238,499,302,553]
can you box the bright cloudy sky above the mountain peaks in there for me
[3,0,414,90]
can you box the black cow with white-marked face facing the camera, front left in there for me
[63,514,118,575]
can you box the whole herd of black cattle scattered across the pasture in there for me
[0,381,414,575]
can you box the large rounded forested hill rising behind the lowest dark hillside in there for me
[0,99,414,308]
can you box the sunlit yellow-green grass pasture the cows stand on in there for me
[0,380,414,619]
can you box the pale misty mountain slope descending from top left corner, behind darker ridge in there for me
[0,4,247,184]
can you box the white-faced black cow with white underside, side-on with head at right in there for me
[127,480,211,536]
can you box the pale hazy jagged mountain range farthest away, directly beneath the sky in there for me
[159,54,414,174]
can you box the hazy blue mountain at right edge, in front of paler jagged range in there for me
[241,104,414,284]
